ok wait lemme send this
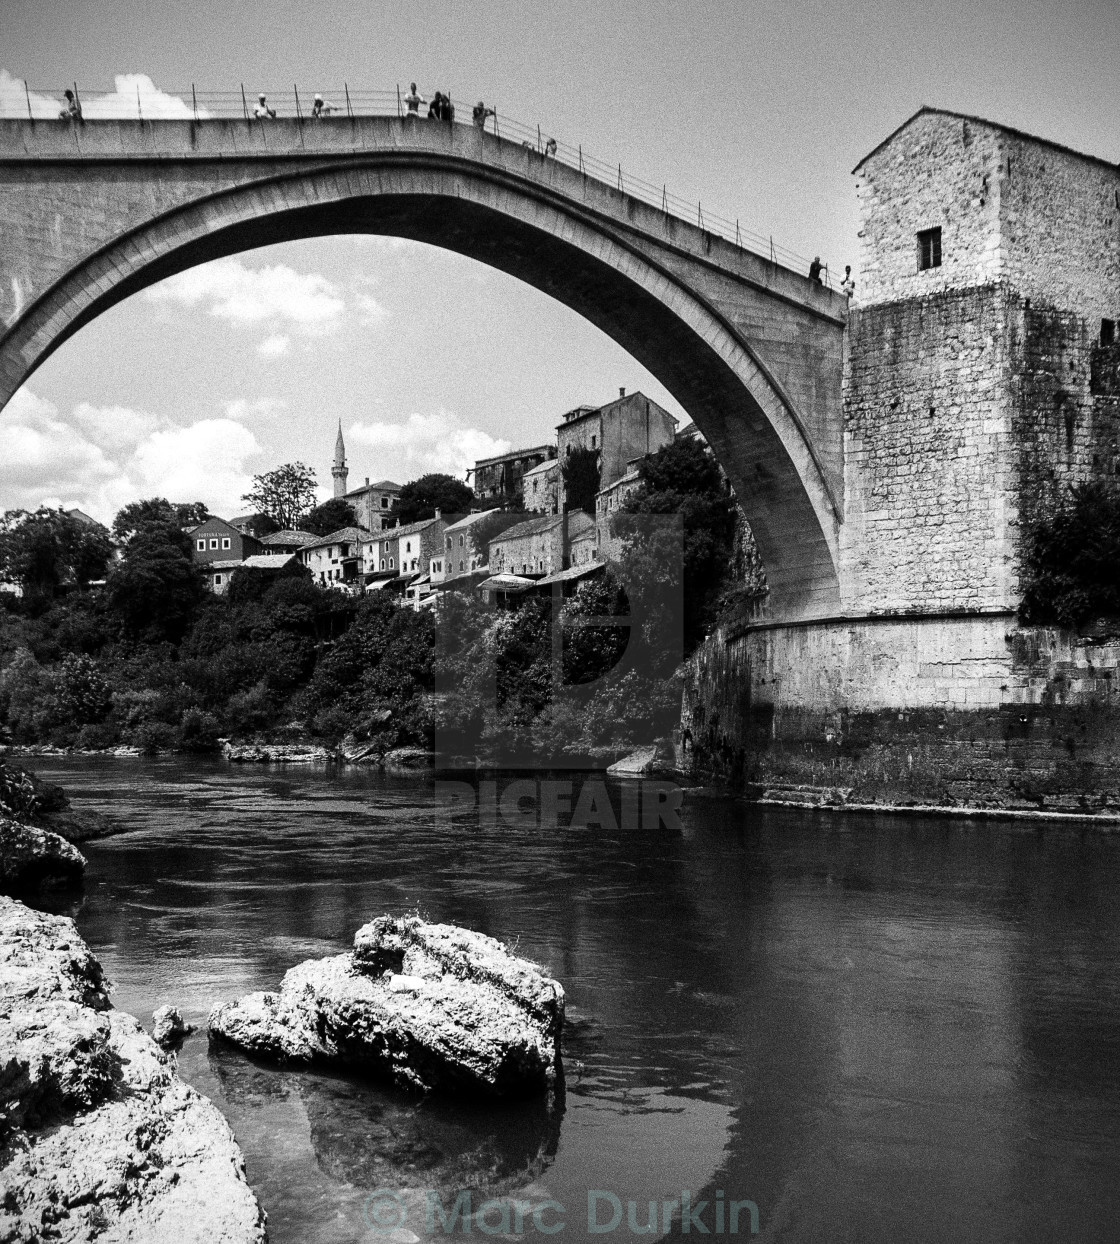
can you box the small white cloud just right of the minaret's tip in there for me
[346,411,511,481]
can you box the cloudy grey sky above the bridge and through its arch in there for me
[0,0,1120,520]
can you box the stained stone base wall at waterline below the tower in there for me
[678,612,1120,811]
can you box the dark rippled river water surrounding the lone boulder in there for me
[24,759,1120,1244]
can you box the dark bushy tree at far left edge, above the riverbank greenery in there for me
[0,506,113,598]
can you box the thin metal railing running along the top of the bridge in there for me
[17,82,836,289]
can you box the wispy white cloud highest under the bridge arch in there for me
[144,259,346,337]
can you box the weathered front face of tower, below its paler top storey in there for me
[840,286,1015,613]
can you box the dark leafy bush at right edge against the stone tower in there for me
[1020,481,1120,627]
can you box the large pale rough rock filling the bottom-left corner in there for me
[0,898,265,1244]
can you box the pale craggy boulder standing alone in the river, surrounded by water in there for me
[210,916,564,1097]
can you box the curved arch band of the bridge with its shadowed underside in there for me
[0,127,840,620]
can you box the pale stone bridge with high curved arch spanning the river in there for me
[0,117,846,621]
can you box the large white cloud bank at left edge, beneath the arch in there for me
[0,388,260,522]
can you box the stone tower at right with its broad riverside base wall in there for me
[683,108,1120,810]
